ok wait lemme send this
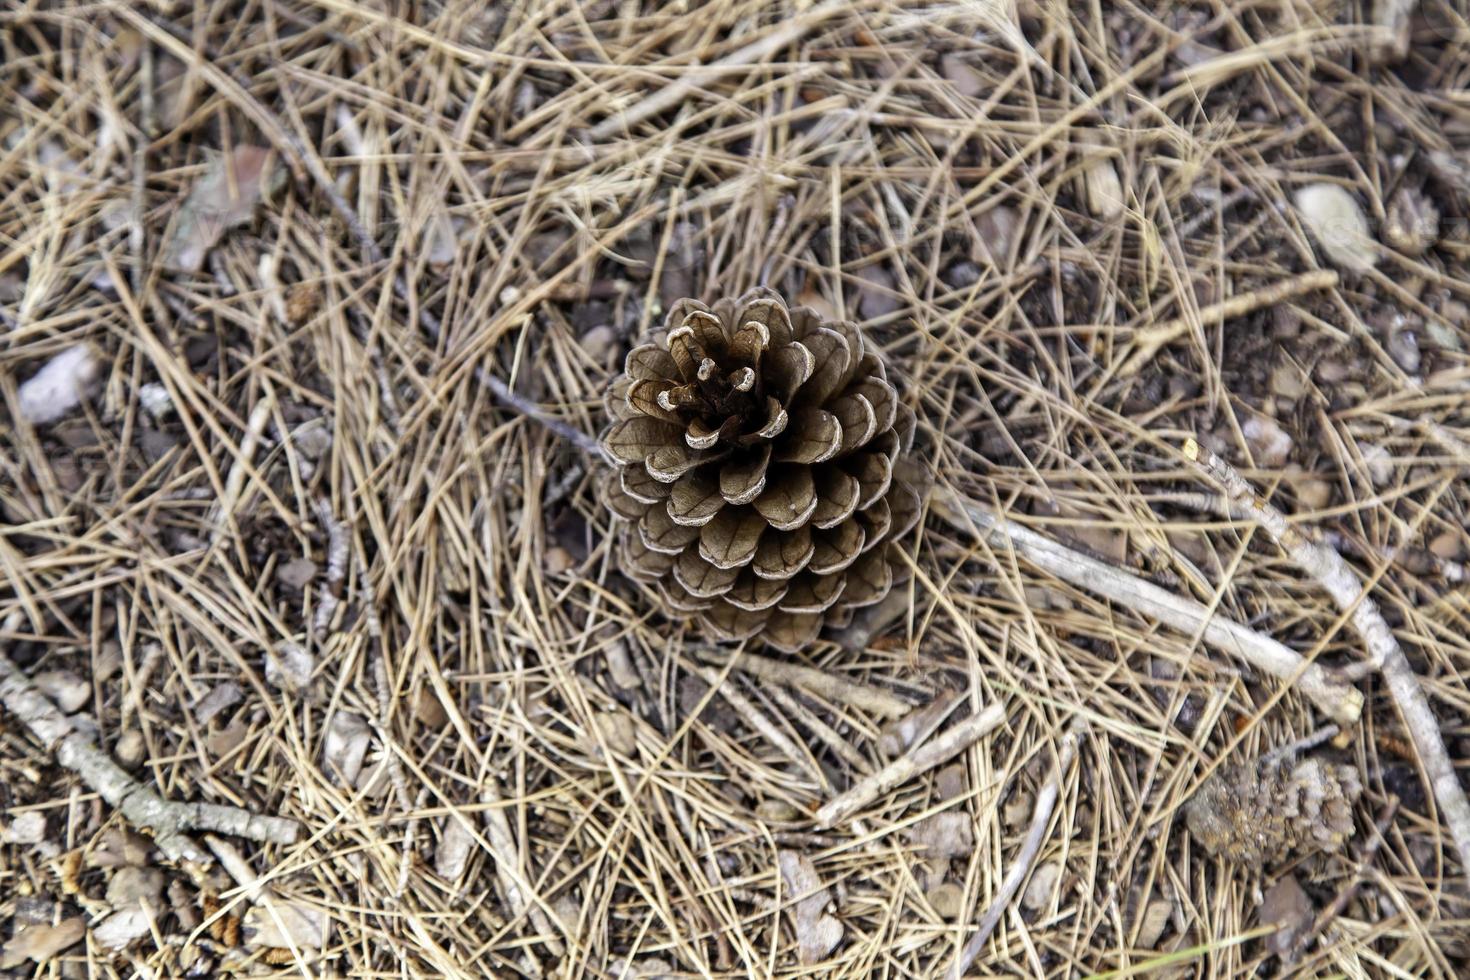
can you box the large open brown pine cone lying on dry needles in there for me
[601,288,919,651]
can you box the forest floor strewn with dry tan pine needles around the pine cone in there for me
[0,0,1470,979]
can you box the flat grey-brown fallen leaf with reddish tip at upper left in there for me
[165,145,285,272]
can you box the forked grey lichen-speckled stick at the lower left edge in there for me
[0,654,301,864]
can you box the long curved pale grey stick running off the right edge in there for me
[1185,439,1470,870]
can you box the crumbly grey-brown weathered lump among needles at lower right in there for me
[1185,758,1363,870]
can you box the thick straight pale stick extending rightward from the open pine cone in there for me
[933,492,1363,726]
